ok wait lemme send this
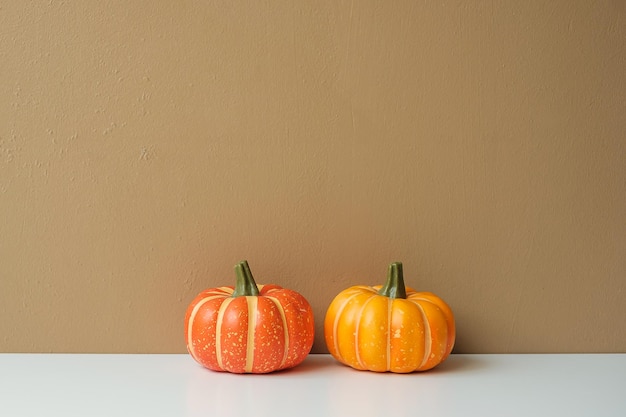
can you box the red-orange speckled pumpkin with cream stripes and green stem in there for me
[185,261,315,373]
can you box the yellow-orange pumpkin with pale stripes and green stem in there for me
[324,262,455,373]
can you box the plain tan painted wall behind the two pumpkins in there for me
[0,0,626,352]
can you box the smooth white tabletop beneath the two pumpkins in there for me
[0,354,626,417]
